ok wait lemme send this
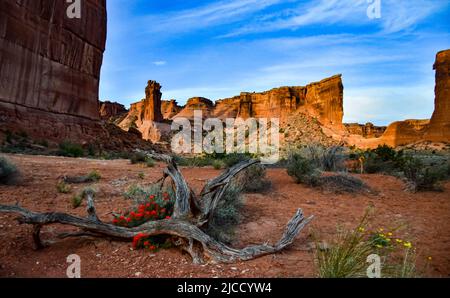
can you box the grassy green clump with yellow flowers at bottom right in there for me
[315,213,419,278]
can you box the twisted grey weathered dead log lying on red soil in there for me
[0,153,312,263]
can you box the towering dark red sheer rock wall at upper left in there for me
[0,0,106,140]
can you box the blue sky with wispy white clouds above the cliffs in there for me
[100,0,450,125]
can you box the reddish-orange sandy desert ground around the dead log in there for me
[0,155,450,277]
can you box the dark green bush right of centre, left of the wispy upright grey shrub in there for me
[287,154,321,186]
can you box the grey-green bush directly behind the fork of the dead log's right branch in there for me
[206,182,243,243]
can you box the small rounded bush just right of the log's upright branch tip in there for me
[238,165,272,193]
